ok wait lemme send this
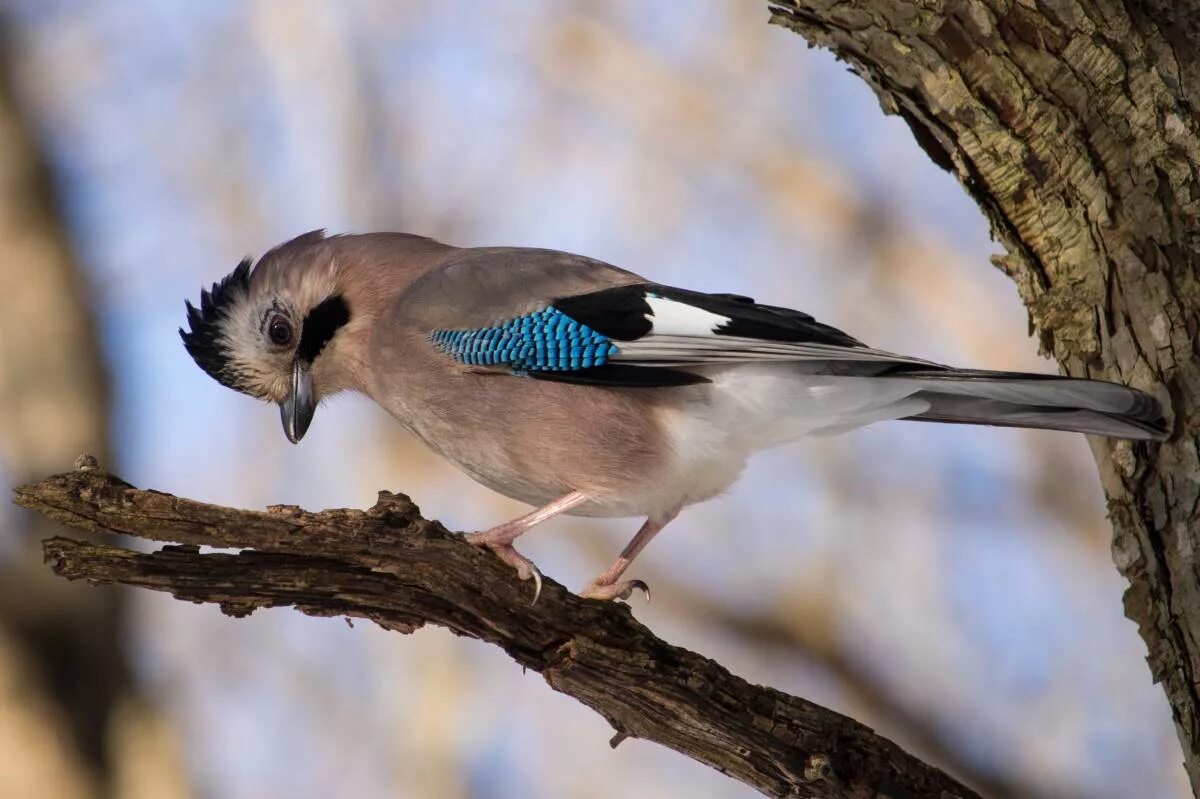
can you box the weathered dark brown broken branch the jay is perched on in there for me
[17,468,977,799]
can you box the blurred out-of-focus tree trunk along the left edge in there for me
[0,19,179,799]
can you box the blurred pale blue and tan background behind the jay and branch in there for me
[0,0,1188,799]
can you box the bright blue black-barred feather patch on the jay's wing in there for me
[430,306,620,372]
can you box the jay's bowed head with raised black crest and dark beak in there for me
[179,230,352,443]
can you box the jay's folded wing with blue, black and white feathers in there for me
[409,257,942,386]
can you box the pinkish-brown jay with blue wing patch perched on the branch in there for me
[179,230,1168,601]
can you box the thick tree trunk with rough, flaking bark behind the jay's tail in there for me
[769,0,1200,792]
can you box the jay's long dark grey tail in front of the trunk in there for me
[897,368,1168,440]
